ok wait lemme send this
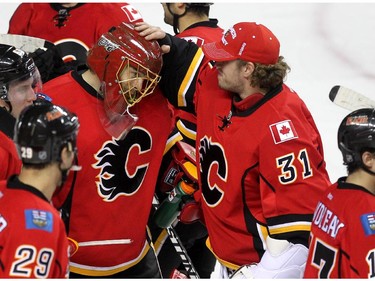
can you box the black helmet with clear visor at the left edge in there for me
[0,44,42,101]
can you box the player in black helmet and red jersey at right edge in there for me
[304,108,375,279]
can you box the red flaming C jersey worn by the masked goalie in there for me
[43,72,171,276]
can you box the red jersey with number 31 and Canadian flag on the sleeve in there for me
[160,38,330,269]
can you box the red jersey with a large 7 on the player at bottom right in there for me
[304,178,375,279]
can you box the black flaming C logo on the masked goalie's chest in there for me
[92,127,151,202]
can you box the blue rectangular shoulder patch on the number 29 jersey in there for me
[25,209,53,232]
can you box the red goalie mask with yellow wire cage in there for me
[87,22,162,110]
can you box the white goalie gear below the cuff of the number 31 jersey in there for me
[231,236,308,279]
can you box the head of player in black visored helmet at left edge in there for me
[0,44,42,117]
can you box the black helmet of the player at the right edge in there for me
[337,108,375,165]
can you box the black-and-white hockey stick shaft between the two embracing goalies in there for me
[153,195,200,279]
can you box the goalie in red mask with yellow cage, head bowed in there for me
[44,23,171,278]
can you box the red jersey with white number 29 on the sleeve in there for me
[0,176,68,278]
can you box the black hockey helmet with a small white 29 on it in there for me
[15,102,79,164]
